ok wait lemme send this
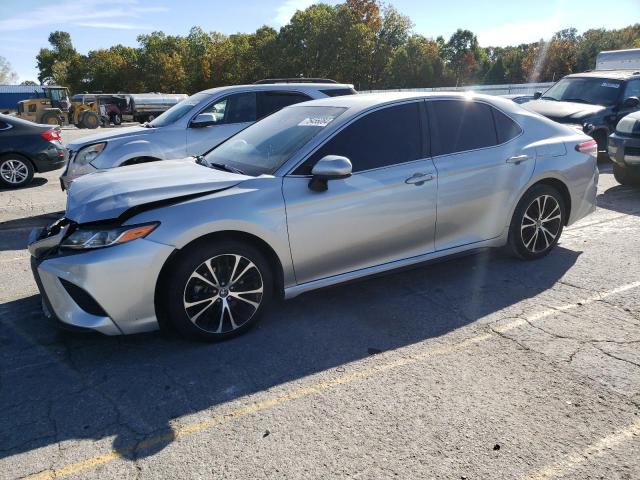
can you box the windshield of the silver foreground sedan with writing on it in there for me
[204,106,346,176]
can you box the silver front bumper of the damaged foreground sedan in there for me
[31,231,174,335]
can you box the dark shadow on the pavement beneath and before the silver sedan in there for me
[0,247,580,459]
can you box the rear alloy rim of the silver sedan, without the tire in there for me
[520,195,562,253]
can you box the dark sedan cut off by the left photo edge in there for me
[0,114,65,188]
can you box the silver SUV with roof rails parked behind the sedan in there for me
[60,79,356,190]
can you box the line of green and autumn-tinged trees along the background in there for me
[36,0,640,93]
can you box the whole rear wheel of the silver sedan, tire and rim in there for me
[509,185,566,260]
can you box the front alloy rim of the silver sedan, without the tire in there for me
[183,254,264,334]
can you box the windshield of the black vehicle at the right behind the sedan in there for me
[542,77,622,105]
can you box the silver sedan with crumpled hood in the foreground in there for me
[29,93,598,340]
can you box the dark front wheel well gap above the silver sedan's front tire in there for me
[154,230,284,328]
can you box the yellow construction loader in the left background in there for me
[18,85,100,129]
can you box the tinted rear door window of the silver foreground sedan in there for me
[429,100,497,155]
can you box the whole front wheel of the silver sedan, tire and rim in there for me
[159,241,273,341]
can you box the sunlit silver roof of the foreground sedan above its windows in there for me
[287,91,521,114]
